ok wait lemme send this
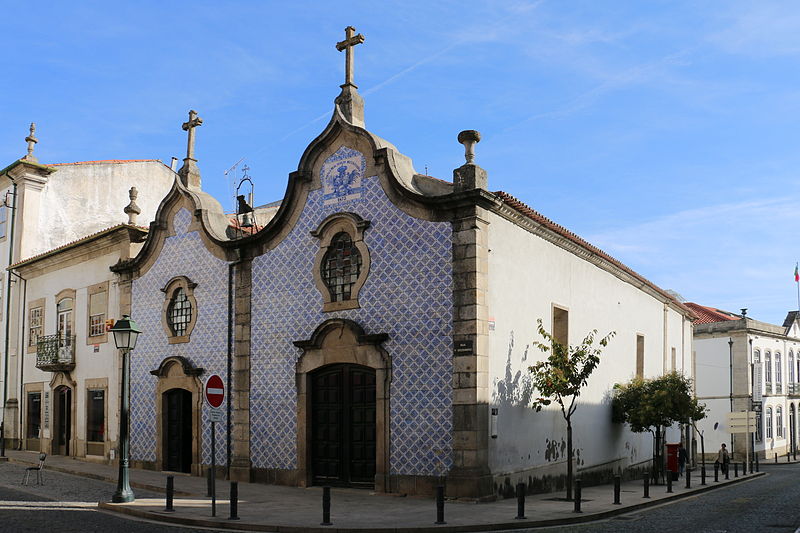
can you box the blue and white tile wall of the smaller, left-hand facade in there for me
[131,208,228,464]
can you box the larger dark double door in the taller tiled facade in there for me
[311,364,375,487]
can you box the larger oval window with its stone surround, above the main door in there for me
[311,213,370,311]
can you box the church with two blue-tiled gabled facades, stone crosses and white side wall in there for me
[113,28,695,498]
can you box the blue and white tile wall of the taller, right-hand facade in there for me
[255,146,453,475]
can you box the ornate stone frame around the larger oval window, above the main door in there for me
[311,212,370,312]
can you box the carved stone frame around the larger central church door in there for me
[294,318,392,492]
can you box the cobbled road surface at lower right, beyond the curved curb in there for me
[496,465,800,533]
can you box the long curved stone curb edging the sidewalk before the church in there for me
[97,472,766,533]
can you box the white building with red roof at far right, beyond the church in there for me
[687,303,800,459]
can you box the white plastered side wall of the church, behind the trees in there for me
[488,214,692,476]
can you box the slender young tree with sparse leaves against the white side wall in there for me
[528,318,614,500]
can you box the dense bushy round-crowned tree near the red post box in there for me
[612,372,706,480]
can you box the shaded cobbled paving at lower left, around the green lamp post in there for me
[0,463,209,533]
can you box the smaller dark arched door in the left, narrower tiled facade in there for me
[162,389,193,473]
